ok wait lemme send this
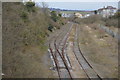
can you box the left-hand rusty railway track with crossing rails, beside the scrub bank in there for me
[49,22,72,78]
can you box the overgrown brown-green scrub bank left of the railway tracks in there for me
[2,2,66,78]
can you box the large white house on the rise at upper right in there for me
[97,6,117,18]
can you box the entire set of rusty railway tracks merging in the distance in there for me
[49,23,102,80]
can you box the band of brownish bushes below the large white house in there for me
[75,12,120,27]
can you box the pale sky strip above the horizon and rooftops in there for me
[34,0,119,10]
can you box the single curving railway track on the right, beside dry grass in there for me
[73,26,102,80]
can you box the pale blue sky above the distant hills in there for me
[47,2,118,10]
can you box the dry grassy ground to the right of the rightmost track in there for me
[79,25,118,78]
